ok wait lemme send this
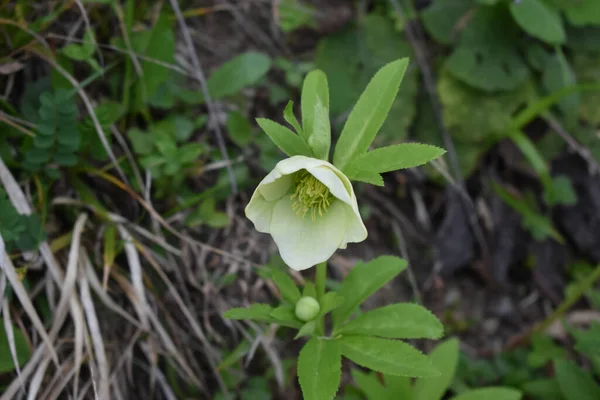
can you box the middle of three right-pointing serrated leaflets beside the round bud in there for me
[335,303,444,339]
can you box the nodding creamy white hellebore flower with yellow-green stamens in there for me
[246,156,367,271]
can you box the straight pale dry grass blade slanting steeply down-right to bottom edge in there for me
[79,251,110,399]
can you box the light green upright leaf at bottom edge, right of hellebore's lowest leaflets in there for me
[413,338,459,400]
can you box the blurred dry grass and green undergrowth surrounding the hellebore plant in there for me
[0,0,600,400]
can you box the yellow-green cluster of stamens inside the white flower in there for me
[290,170,335,221]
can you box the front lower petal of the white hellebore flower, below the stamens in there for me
[270,196,347,271]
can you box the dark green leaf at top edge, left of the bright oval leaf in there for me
[421,0,474,44]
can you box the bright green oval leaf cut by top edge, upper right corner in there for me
[509,0,566,44]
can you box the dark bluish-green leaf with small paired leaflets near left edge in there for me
[23,90,81,174]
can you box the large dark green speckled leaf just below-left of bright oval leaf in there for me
[445,5,529,92]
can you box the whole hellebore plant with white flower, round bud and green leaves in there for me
[224,59,444,400]
